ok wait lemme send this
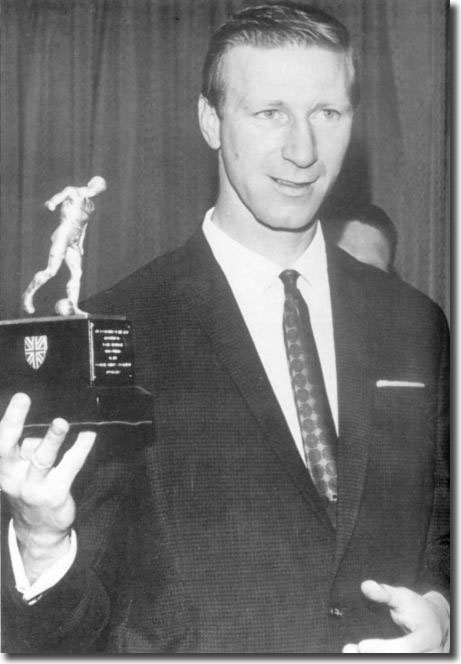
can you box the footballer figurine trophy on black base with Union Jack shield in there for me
[0,176,152,451]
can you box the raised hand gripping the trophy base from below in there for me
[0,393,96,583]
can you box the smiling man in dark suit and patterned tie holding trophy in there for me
[0,4,448,653]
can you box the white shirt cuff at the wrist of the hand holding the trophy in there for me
[8,519,77,604]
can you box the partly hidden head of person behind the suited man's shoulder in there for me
[326,204,397,272]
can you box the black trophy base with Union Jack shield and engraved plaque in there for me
[0,315,152,446]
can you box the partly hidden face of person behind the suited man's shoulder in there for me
[338,220,391,272]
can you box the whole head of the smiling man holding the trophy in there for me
[199,3,357,245]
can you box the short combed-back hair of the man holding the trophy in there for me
[201,1,360,111]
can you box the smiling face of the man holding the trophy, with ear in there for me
[200,45,352,239]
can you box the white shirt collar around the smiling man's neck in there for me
[202,208,328,297]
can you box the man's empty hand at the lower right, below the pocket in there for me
[343,581,449,653]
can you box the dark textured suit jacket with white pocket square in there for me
[3,226,449,653]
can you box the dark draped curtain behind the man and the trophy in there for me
[0,0,449,318]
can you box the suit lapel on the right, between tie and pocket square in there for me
[328,247,372,571]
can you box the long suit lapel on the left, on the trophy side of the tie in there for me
[180,232,331,527]
